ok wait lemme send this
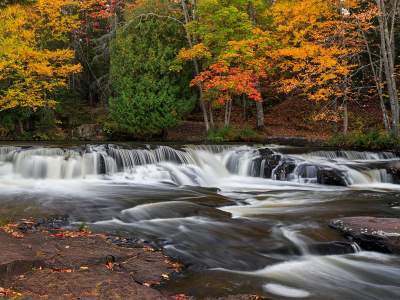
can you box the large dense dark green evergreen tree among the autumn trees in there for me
[110,0,195,136]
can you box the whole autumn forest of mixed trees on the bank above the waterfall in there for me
[0,0,400,146]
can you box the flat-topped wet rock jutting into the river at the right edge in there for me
[330,217,400,254]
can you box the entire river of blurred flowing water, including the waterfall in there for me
[0,145,400,299]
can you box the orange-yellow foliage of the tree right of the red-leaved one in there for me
[269,0,359,113]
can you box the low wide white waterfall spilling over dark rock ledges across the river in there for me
[0,145,400,186]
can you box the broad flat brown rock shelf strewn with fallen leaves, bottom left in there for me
[0,219,261,300]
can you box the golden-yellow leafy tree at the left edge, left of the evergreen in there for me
[0,0,81,111]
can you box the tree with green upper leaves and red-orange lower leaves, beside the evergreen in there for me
[178,1,265,128]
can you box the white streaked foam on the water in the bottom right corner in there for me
[216,252,400,300]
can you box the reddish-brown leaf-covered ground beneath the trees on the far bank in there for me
[166,98,381,146]
